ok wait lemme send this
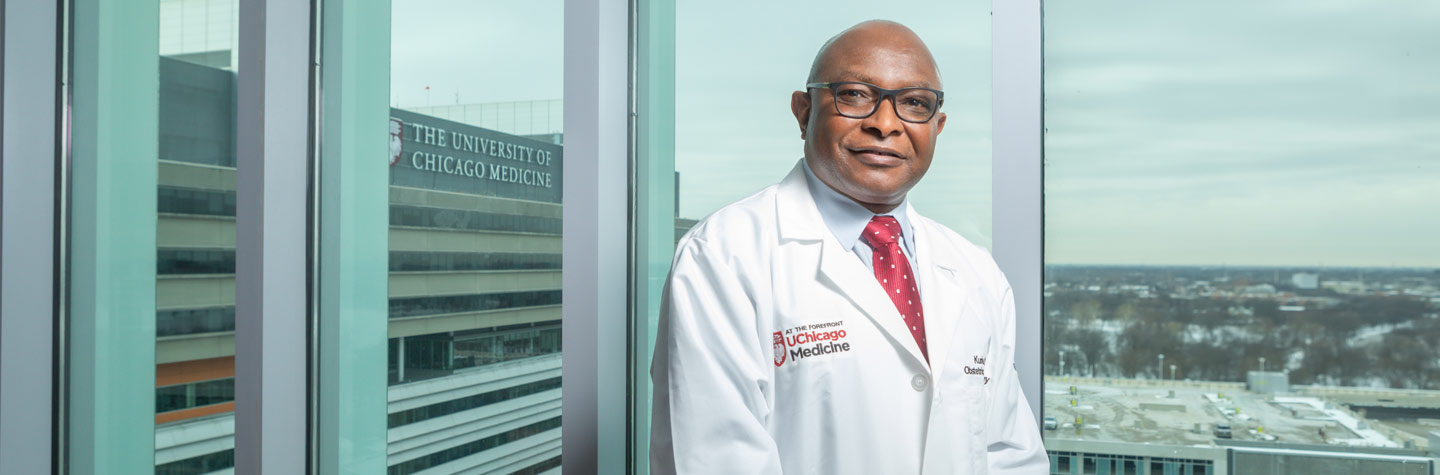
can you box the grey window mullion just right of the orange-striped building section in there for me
[235,0,311,474]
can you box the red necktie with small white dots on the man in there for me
[861,216,930,363]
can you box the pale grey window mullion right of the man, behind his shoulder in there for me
[991,0,1044,422]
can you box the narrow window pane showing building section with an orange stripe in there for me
[156,0,239,474]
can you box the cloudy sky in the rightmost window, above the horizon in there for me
[1045,1,1440,266]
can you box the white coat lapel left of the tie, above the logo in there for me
[819,239,933,366]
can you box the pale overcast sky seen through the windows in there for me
[392,0,1440,268]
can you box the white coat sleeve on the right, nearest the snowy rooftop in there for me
[986,288,1050,475]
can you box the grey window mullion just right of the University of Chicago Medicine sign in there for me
[562,0,629,474]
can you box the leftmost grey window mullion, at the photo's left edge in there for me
[0,0,59,474]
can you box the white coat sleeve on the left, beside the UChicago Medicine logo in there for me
[649,240,780,474]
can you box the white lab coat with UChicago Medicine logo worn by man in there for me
[649,161,1050,475]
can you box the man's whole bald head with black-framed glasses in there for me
[791,20,945,213]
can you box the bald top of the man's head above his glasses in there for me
[806,20,942,89]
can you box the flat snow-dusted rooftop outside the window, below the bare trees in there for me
[1044,377,1440,451]
